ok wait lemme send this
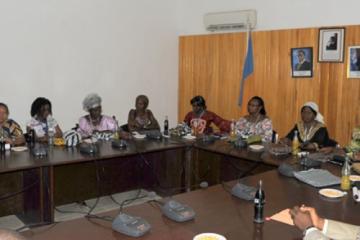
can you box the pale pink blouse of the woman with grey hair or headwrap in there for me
[78,115,116,137]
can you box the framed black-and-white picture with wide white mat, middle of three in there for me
[319,28,345,62]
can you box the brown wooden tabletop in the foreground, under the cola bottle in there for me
[23,166,360,240]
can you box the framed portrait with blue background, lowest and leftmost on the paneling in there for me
[291,47,313,77]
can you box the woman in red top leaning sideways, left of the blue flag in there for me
[184,96,230,134]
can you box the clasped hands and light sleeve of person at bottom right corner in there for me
[290,205,360,240]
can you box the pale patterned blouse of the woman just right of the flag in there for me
[235,117,273,142]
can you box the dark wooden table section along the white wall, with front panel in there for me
[0,139,189,223]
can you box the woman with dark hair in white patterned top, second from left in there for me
[26,97,62,142]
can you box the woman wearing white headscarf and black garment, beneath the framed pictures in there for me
[282,102,337,151]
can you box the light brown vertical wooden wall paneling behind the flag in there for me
[179,26,360,145]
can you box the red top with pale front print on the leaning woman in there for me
[184,111,230,134]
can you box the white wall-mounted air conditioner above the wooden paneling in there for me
[204,9,256,32]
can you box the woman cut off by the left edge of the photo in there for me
[0,103,25,145]
